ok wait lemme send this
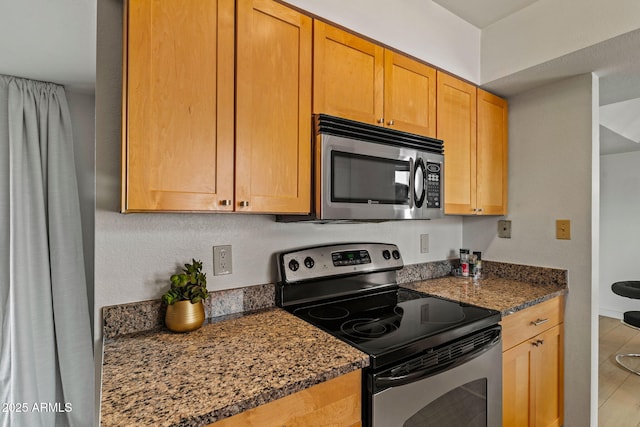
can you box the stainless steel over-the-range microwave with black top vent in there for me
[279,114,444,222]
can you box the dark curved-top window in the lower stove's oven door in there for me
[403,378,487,427]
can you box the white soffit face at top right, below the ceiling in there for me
[481,0,640,84]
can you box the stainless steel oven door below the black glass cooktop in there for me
[370,330,502,427]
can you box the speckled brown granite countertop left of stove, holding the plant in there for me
[101,308,369,427]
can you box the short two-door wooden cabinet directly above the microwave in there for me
[313,21,436,137]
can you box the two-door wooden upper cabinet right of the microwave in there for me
[436,72,508,215]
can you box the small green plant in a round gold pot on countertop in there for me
[162,259,209,332]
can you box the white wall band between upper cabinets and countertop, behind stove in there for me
[95,212,462,336]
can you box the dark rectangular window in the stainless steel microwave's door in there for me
[331,151,410,205]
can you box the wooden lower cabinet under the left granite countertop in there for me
[208,370,362,427]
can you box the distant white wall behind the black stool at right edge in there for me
[600,151,640,319]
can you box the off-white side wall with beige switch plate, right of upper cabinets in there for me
[463,75,597,426]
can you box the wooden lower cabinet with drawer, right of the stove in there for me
[502,297,564,427]
